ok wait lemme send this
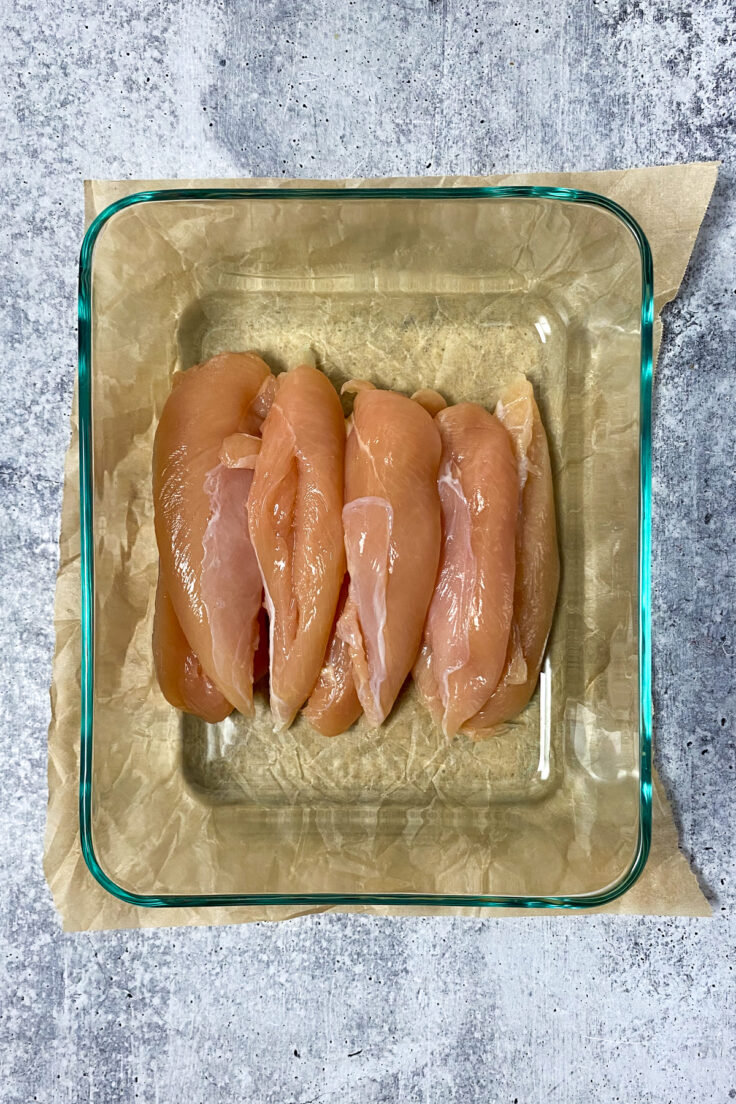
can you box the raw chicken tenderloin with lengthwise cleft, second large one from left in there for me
[248,364,345,728]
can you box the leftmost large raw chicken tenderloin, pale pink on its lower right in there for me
[153,353,270,715]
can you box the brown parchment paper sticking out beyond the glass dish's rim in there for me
[44,162,718,931]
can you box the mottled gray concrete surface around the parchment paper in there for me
[0,0,736,1104]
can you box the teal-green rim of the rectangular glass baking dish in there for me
[78,185,653,910]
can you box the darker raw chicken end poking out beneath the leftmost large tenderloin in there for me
[153,576,233,724]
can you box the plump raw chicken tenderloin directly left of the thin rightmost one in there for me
[414,403,519,736]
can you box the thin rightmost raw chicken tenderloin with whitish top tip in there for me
[463,375,559,735]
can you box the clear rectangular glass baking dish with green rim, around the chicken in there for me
[79,187,652,909]
